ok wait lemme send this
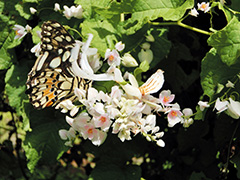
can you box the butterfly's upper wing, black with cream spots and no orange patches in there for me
[29,21,75,77]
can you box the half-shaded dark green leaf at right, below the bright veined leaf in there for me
[200,48,240,100]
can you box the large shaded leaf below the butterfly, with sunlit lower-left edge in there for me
[23,107,68,172]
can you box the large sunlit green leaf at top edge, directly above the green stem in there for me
[122,0,194,34]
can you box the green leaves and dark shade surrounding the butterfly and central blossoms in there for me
[0,0,240,180]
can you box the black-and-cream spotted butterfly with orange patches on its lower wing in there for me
[26,21,92,109]
